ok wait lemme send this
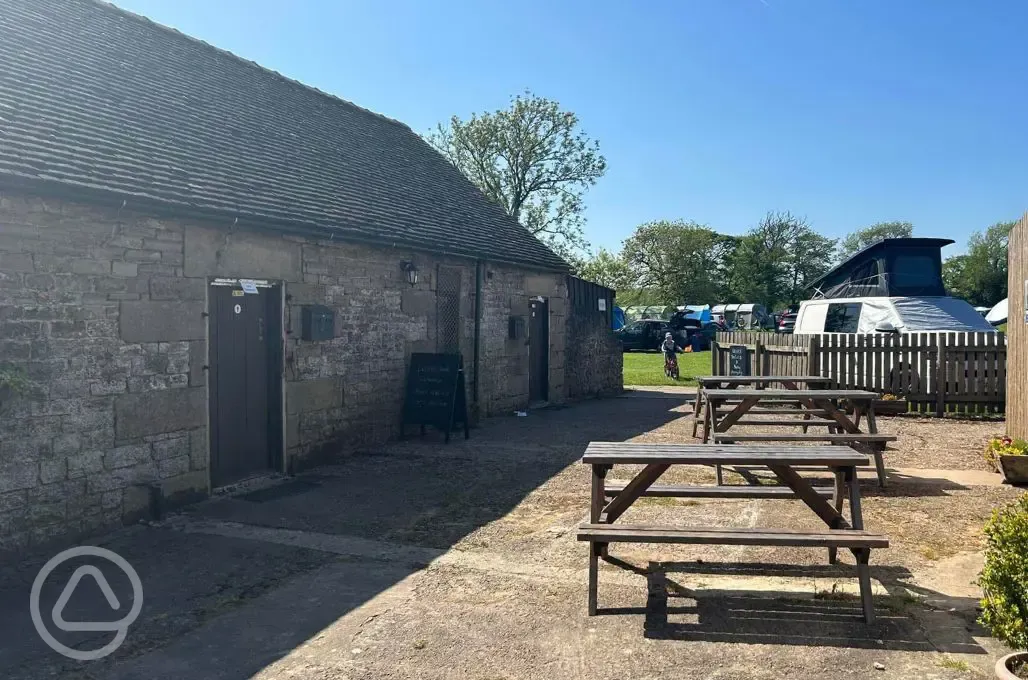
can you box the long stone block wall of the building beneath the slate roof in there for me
[0,193,566,550]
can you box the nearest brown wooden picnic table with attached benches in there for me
[578,441,889,623]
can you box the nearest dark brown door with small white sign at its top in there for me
[209,285,282,487]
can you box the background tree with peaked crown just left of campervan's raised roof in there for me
[731,212,836,308]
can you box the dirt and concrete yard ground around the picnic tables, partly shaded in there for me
[0,391,1020,680]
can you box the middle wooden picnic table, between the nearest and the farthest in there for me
[703,389,895,488]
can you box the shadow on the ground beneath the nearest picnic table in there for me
[598,557,988,654]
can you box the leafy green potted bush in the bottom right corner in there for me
[978,494,1028,680]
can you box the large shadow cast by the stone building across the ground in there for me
[0,394,686,680]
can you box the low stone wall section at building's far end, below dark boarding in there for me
[566,302,625,399]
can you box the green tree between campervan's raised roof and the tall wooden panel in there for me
[943,222,1015,307]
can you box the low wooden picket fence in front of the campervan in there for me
[710,331,1006,416]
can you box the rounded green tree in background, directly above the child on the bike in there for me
[622,220,735,305]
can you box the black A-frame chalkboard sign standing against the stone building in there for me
[402,352,470,441]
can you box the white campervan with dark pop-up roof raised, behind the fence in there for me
[794,239,994,334]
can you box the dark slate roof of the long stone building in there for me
[0,0,567,271]
